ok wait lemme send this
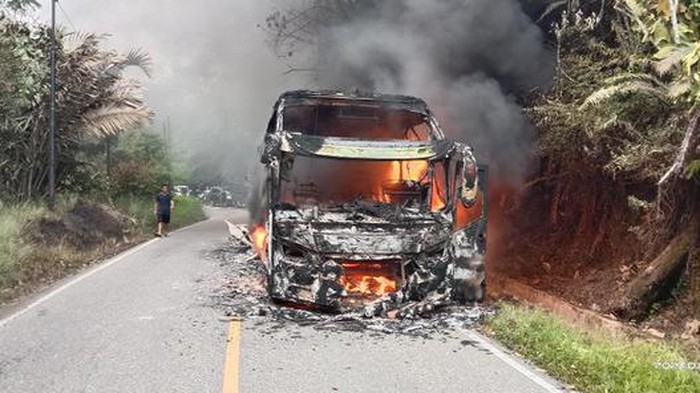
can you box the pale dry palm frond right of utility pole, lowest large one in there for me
[82,102,153,137]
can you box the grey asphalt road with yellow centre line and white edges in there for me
[0,209,561,393]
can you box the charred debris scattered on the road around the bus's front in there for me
[209,237,491,336]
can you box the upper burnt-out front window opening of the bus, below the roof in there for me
[282,103,435,141]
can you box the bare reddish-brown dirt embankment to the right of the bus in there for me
[489,168,700,341]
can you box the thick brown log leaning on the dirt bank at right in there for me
[612,215,700,319]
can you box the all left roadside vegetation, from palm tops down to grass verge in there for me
[0,0,205,303]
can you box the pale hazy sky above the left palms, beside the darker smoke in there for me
[38,0,302,173]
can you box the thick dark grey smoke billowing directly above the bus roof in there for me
[308,0,554,179]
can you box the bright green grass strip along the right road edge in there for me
[485,304,700,393]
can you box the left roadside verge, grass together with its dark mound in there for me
[0,194,206,304]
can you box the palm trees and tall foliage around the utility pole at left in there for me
[0,7,152,200]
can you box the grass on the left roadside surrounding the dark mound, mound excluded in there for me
[0,196,206,304]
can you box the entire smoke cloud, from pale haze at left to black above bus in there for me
[40,0,553,184]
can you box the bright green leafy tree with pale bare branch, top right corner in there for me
[584,0,700,185]
